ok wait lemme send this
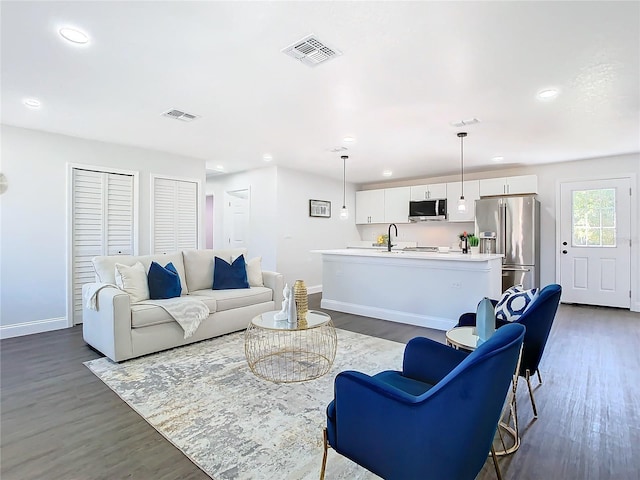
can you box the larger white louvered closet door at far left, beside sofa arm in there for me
[72,169,134,325]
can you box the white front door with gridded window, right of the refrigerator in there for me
[558,178,631,308]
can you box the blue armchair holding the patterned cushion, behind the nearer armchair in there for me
[456,283,562,417]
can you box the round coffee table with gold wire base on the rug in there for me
[244,310,338,383]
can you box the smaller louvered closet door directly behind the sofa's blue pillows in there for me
[153,178,198,253]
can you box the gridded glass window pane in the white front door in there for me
[571,188,616,247]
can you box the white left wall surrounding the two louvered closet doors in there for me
[0,125,205,336]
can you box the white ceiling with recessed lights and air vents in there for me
[1,1,640,183]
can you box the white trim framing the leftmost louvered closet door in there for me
[65,162,140,327]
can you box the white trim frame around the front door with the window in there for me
[555,172,640,312]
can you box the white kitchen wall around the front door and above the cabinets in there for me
[359,154,640,311]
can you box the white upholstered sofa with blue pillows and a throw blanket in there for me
[82,249,284,362]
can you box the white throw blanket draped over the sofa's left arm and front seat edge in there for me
[82,283,210,338]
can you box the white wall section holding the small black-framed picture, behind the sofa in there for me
[207,166,360,292]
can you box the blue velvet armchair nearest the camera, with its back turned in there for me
[320,325,525,480]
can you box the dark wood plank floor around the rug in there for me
[0,294,640,480]
